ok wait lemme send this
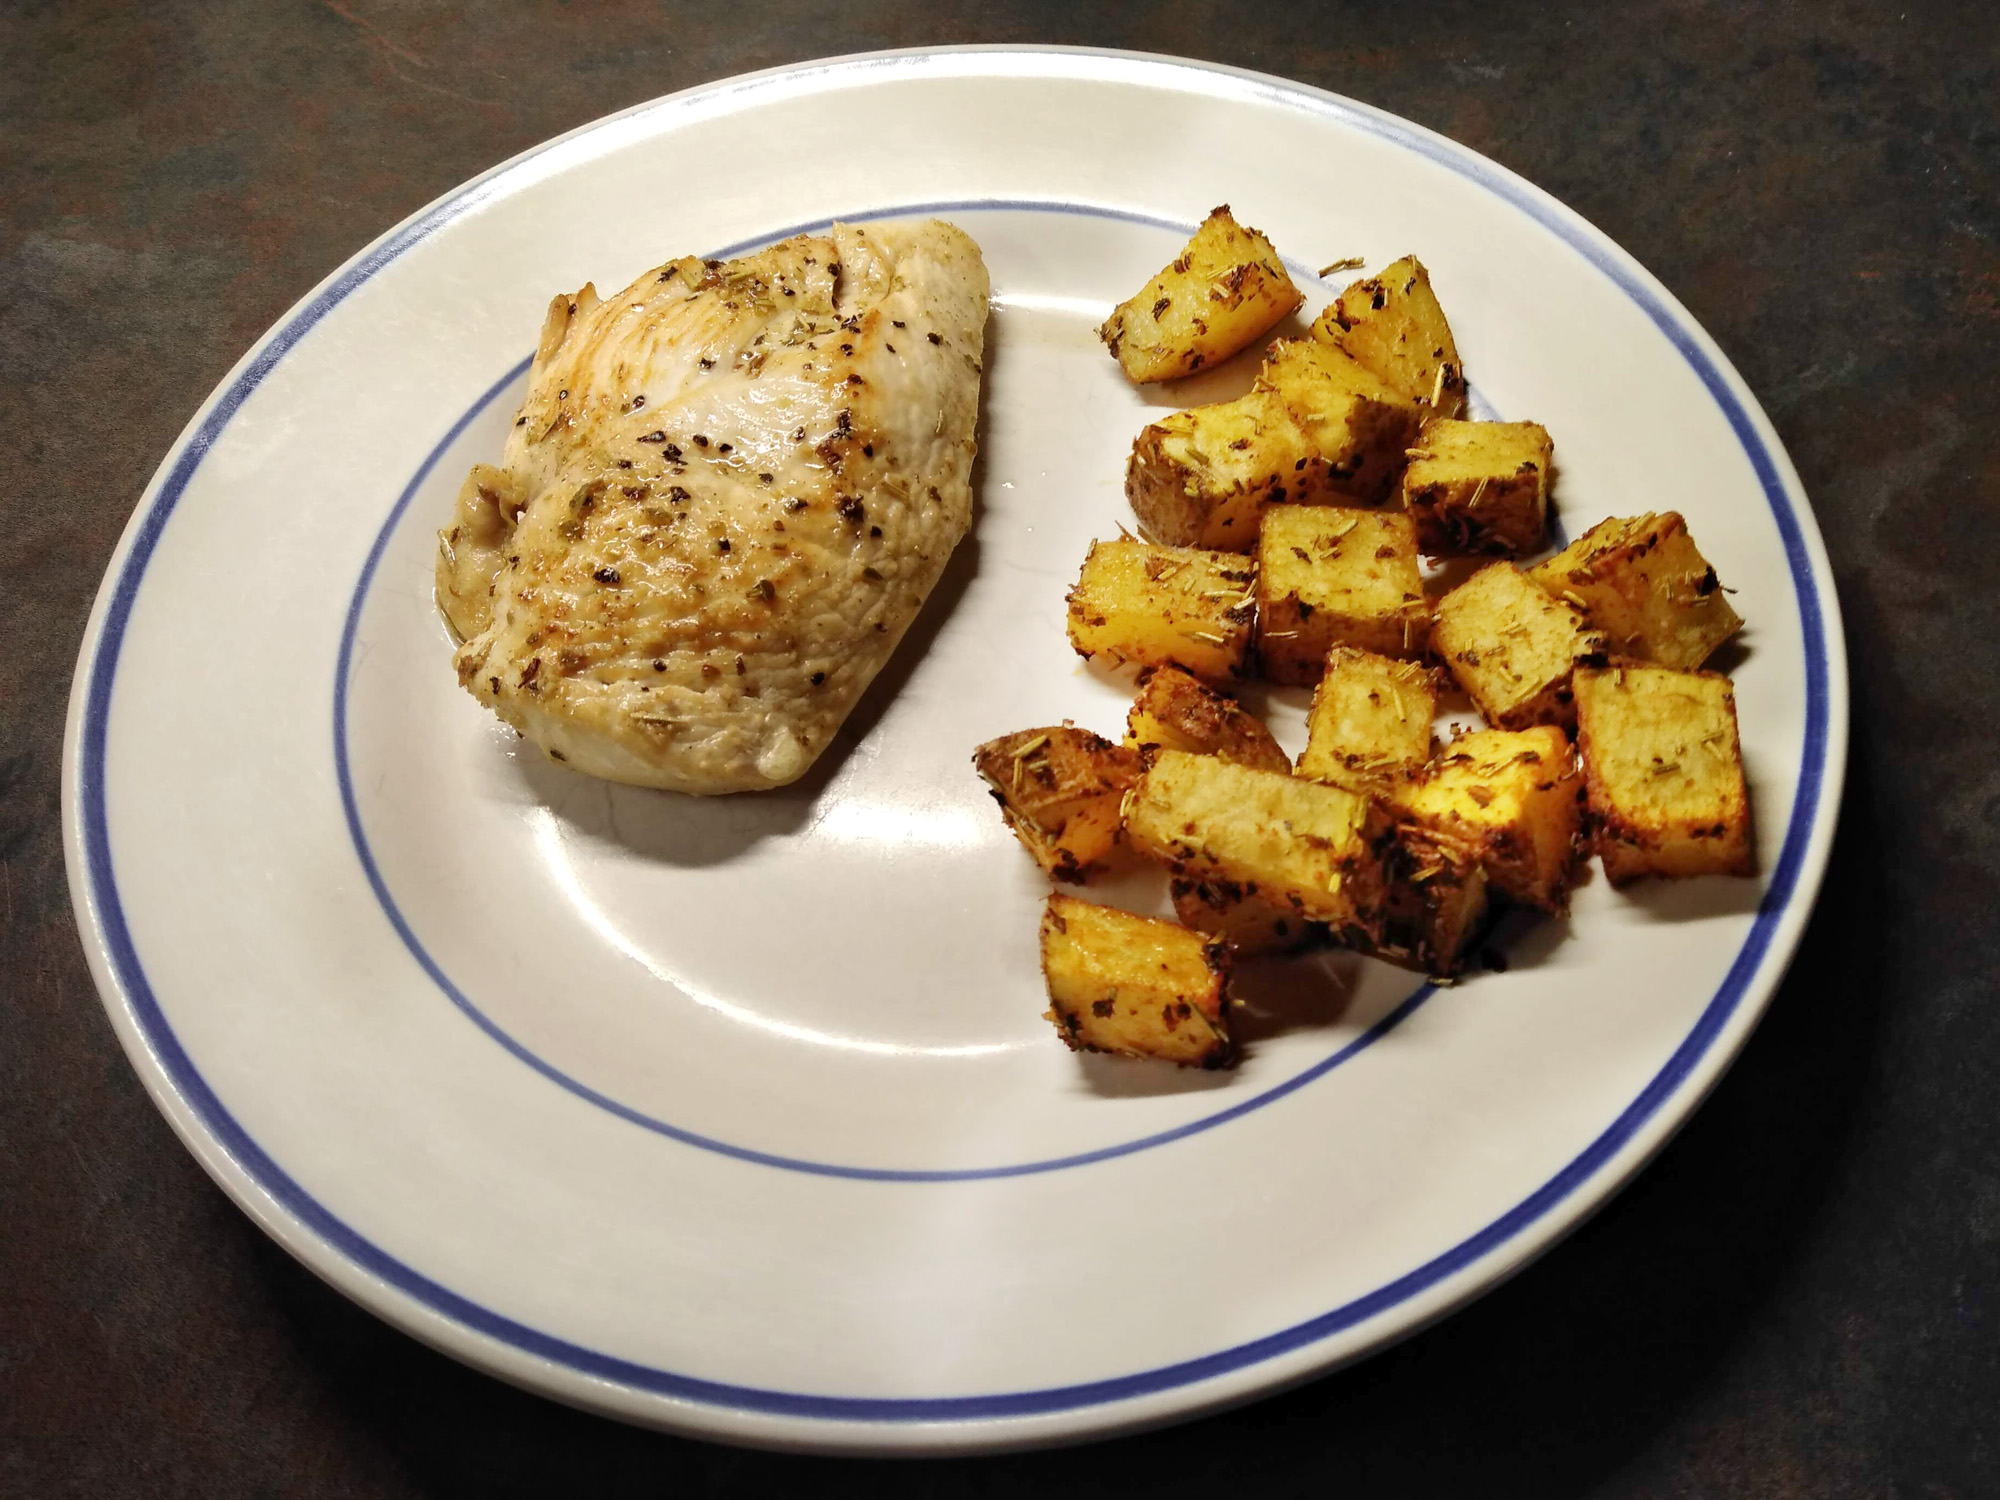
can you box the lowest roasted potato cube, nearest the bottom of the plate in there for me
[1042,892,1236,1068]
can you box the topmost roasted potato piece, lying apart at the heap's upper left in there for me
[1098,204,1306,382]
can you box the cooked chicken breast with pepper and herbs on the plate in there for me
[438,220,988,792]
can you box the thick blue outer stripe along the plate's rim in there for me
[78,52,1832,1424]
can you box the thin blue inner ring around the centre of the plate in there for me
[334,200,1436,1182]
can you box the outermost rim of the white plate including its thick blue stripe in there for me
[62,44,1848,1452]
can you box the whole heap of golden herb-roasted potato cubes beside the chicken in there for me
[976,223,1754,1068]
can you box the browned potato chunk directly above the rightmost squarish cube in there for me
[1528,510,1744,672]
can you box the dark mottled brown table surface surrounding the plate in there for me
[0,0,2000,1500]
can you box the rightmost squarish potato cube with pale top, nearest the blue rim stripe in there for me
[1576,664,1754,886]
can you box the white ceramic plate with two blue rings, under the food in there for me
[64,50,1846,1450]
